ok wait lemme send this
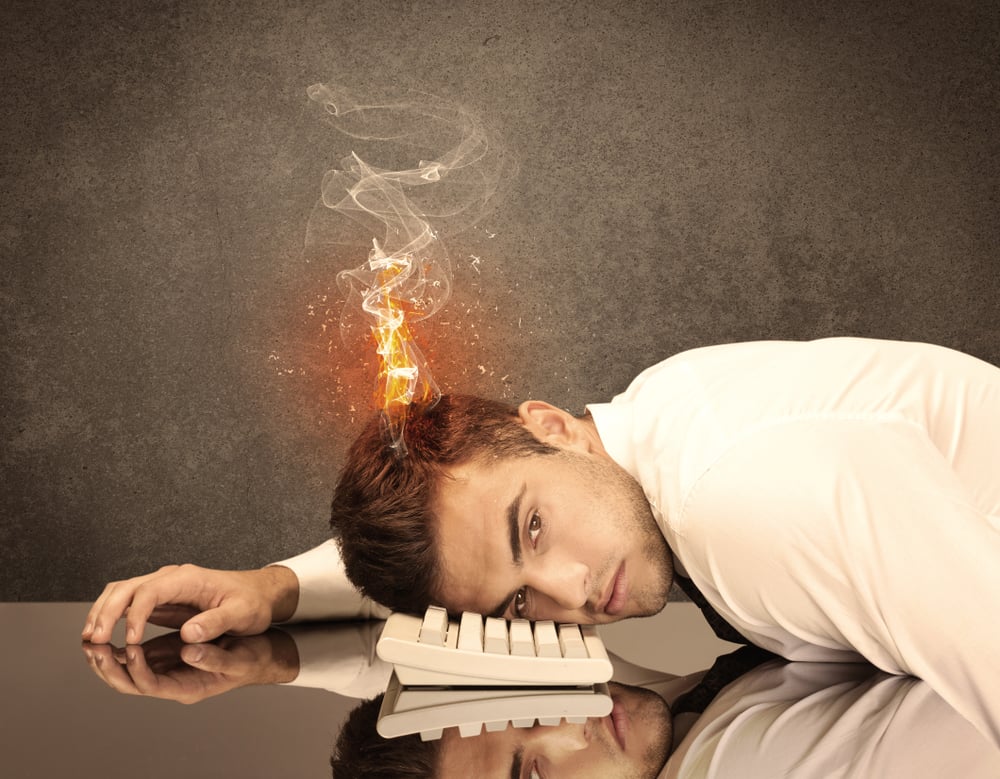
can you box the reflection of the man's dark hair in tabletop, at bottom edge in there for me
[330,695,441,779]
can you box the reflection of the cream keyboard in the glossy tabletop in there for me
[376,674,613,741]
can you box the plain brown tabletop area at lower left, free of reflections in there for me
[0,603,357,779]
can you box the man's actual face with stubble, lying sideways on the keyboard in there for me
[433,447,673,623]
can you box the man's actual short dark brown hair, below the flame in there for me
[330,395,558,612]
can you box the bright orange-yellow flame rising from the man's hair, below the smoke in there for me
[364,244,440,456]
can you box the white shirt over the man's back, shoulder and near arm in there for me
[589,338,1000,744]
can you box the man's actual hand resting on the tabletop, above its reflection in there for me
[83,565,299,644]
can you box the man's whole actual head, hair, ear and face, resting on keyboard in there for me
[331,396,672,622]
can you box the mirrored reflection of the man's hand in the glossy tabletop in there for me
[83,630,299,703]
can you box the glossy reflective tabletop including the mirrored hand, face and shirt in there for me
[0,603,1000,779]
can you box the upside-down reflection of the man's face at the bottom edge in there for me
[438,684,671,779]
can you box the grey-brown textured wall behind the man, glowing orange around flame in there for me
[0,0,1000,600]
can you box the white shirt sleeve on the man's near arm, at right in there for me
[678,418,1000,745]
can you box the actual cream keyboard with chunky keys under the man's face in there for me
[377,606,612,687]
